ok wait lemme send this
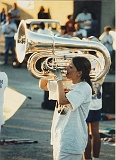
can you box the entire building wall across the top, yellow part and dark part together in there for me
[0,0,116,34]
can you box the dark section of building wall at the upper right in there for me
[74,0,116,35]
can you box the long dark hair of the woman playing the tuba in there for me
[72,57,94,94]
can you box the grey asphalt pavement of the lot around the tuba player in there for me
[0,56,115,160]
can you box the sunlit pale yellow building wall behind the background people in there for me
[0,0,73,25]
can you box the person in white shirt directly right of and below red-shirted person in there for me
[73,23,87,39]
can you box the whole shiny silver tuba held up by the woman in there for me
[16,20,111,81]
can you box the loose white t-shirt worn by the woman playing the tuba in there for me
[48,82,92,154]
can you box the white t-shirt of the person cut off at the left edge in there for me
[0,72,8,125]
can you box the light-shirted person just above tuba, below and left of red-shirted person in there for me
[55,26,71,38]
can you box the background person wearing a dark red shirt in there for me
[65,15,75,36]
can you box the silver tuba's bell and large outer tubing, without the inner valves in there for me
[16,20,111,81]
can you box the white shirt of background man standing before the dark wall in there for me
[75,12,92,29]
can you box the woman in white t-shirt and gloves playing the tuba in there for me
[39,57,93,160]
